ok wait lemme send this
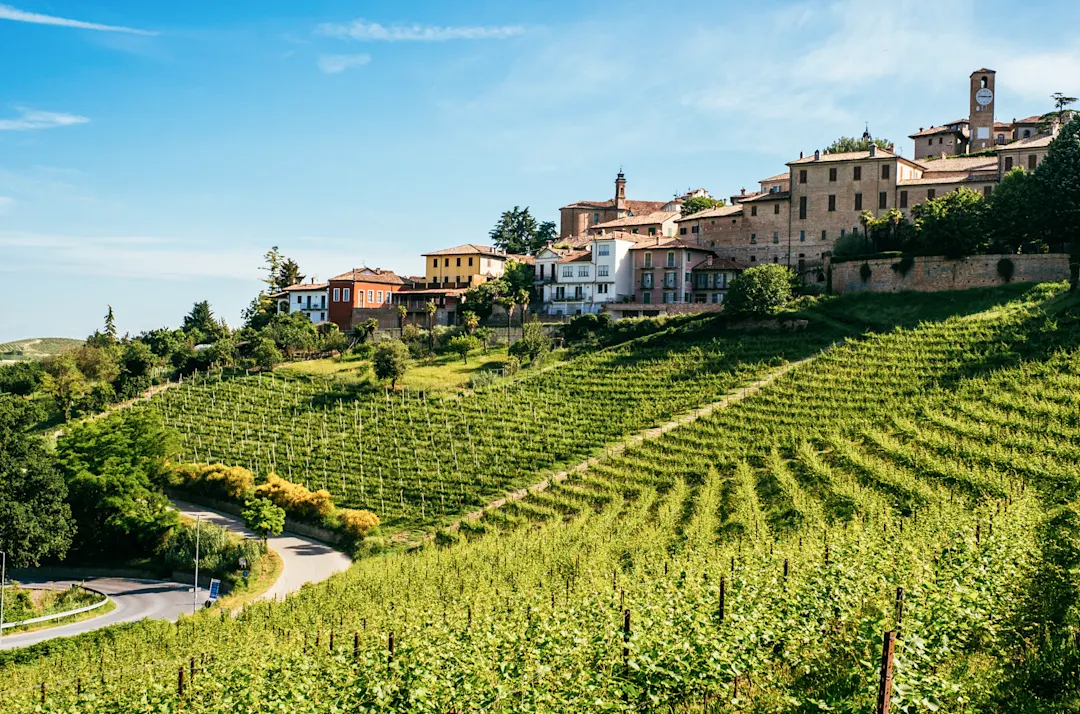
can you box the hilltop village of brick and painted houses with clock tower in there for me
[273,68,1062,331]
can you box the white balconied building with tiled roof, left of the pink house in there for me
[536,232,647,315]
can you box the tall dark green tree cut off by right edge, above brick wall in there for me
[1034,116,1080,243]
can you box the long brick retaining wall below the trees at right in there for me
[832,253,1069,295]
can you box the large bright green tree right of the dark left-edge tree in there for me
[56,409,178,558]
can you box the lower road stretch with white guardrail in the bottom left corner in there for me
[0,577,200,649]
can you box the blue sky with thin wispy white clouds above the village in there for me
[0,0,1080,341]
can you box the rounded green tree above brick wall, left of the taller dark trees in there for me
[912,188,989,258]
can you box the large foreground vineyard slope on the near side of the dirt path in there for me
[0,286,1080,714]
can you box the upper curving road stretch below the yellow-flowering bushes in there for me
[173,500,352,600]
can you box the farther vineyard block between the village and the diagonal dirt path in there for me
[148,332,828,528]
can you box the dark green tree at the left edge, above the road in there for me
[0,396,75,568]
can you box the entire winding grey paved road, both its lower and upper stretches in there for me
[0,501,352,649]
